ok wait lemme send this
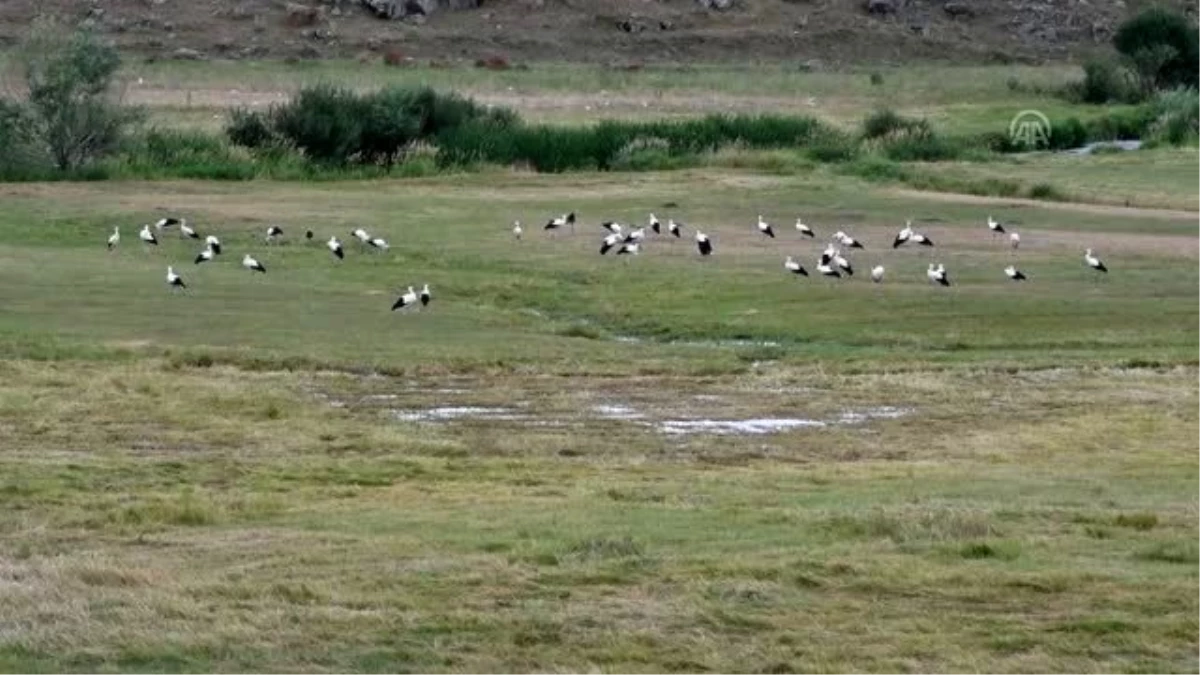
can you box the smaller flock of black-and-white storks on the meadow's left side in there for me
[108,216,433,311]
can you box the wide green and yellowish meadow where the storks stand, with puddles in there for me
[0,159,1200,673]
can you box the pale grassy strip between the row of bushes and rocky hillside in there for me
[112,61,1104,133]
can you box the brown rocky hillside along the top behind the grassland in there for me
[0,0,1180,67]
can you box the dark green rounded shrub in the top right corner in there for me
[1112,7,1200,94]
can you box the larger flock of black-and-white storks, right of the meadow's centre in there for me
[530,211,1109,286]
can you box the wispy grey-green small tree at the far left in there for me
[17,20,138,171]
